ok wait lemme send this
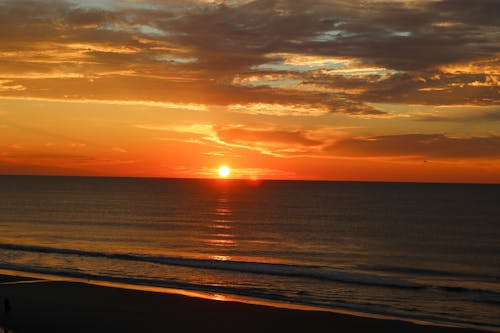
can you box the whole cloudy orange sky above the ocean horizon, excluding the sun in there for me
[0,0,500,183]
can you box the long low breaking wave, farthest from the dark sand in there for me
[0,243,425,289]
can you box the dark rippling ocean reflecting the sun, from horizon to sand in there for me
[0,176,500,331]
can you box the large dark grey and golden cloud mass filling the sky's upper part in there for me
[0,0,500,116]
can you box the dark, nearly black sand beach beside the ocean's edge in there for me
[0,275,492,333]
